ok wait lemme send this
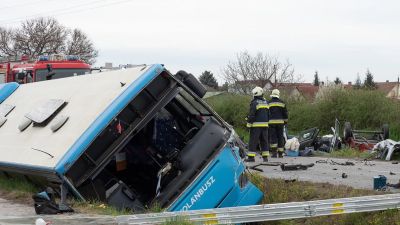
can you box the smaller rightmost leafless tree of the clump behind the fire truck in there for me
[66,29,98,64]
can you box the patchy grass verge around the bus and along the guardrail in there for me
[0,173,400,225]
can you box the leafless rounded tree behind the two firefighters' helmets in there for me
[222,51,301,93]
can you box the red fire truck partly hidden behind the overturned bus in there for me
[0,54,90,84]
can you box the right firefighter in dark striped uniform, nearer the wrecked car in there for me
[268,89,288,158]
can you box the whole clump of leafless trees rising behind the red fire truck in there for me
[0,17,98,63]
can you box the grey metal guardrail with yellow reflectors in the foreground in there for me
[116,194,400,225]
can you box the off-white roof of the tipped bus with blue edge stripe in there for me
[0,65,164,174]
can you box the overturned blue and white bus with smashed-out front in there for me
[0,65,262,211]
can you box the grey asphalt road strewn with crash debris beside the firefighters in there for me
[248,157,400,192]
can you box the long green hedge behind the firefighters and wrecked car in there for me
[207,89,400,140]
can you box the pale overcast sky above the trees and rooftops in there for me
[0,0,400,82]
